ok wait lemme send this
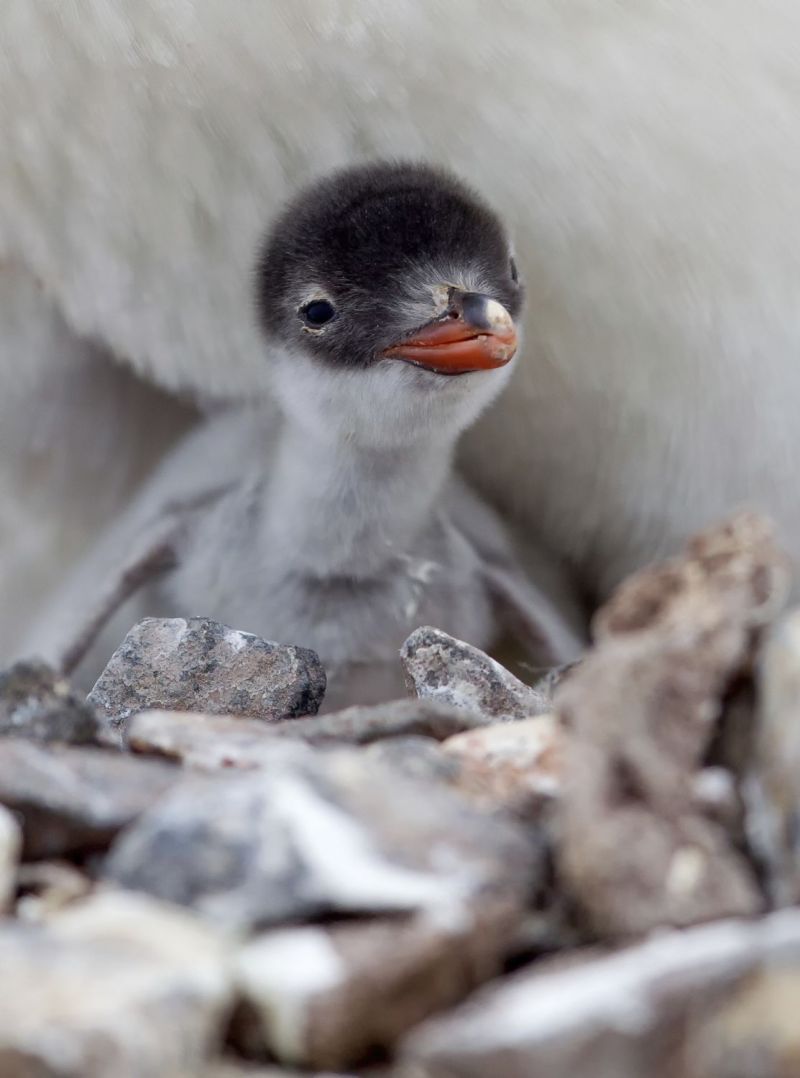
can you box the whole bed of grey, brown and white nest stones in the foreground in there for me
[0,515,800,1078]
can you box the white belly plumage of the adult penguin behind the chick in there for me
[0,0,800,657]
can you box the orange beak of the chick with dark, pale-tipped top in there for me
[381,292,516,374]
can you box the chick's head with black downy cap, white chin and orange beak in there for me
[257,163,522,444]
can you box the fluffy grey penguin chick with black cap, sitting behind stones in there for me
[28,163,580,706]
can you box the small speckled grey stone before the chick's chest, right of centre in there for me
[400,625,550,721]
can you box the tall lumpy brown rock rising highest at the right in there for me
[556,514,788,936]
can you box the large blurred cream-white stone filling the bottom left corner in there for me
[0,896,231,1078]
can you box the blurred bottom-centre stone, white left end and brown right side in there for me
[231,909,526,1069]
